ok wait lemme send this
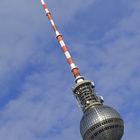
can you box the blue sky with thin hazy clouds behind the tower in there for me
[0,0,140,140]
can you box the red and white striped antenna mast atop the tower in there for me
[41,0,84,83]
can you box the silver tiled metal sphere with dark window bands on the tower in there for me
[80,105,124,140]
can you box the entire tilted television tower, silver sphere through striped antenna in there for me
[41,0,124,140]
